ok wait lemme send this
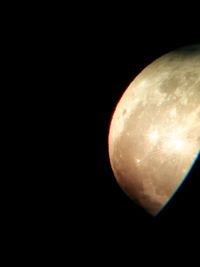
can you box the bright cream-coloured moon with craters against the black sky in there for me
[108,44,200,215]
